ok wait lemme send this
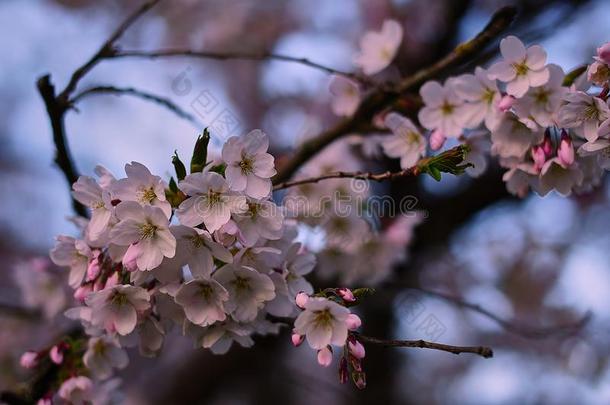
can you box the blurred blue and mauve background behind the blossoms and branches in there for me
[0,0,610,405]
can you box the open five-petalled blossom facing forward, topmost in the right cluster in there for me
[489,35,549,98]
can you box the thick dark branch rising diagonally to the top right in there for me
[273,6,517,184]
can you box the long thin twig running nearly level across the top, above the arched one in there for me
[107,49,375,85]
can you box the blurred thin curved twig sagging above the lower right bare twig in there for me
[407,287,592,339]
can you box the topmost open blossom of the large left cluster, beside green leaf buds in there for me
[222,129,276,198]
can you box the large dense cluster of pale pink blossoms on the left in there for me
[42,130,315,402]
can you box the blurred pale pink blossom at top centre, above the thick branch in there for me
[354,20,402,75]
